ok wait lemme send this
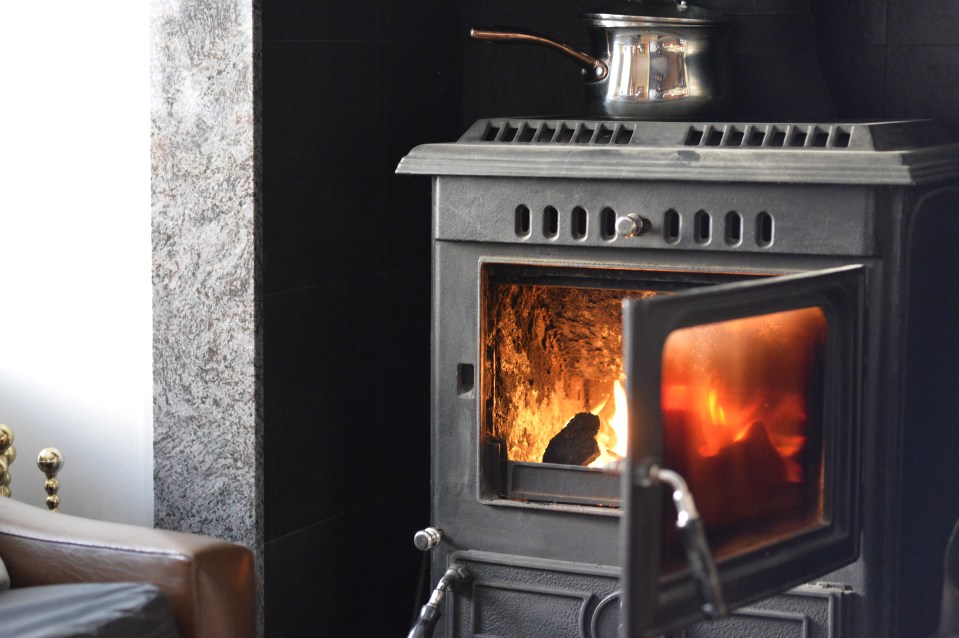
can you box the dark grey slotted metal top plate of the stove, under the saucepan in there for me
[397,118,959,184]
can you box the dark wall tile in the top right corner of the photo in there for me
[887,0,959,45]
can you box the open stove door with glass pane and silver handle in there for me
[620,266,865,638]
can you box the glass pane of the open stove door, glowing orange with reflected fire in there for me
[662,308,826,564]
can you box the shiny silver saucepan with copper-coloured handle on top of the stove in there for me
[470,0,729,119]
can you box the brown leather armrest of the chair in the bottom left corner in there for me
[0,498,257,638]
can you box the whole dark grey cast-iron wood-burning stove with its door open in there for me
[398,119,959,638]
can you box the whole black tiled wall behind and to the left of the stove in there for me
[262,0,959,636]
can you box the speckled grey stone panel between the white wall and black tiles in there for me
[151,0,263,555]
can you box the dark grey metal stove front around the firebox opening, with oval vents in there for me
[433,172,877,637]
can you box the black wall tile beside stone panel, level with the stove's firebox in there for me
[263,276,386,540]
